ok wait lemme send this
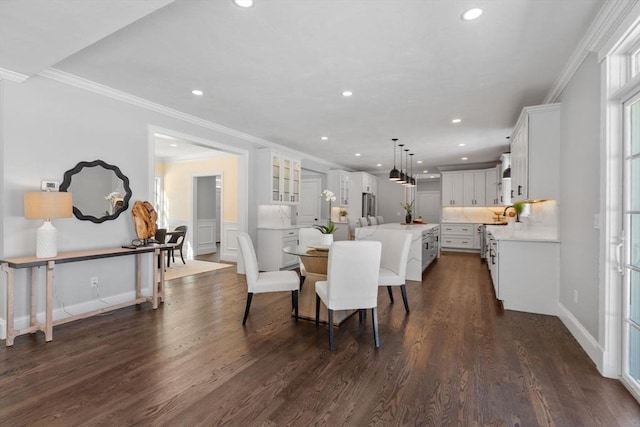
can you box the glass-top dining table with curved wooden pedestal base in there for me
[282,244,357,326]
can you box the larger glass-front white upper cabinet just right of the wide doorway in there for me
[256,149,301,205]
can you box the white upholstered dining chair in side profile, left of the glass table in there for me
[238,233,300,325]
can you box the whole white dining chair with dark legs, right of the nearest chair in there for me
[357,229,411,313]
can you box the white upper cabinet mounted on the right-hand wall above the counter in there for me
[511,104,560,202]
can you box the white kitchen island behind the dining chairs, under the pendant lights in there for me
[356,223,440,282]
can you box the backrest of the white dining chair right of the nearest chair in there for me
[356,229,411,279]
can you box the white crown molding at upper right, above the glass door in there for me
[544,0,639,104]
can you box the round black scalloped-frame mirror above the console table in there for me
[60,160,131,223]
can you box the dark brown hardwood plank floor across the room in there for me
[0,253,640,426]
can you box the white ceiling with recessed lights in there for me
[0,0,604,176]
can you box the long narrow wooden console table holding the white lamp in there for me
[0,244,174,347]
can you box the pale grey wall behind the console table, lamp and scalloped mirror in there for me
[0,76,256,336]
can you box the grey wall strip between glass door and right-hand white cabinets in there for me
[559,54,601,339]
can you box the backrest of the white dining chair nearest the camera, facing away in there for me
[327,241,382,310]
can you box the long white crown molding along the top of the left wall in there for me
[38,68,345,169]
